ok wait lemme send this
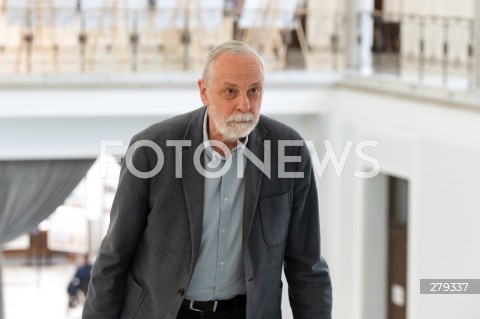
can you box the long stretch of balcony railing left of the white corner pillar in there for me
[0,0,343,74]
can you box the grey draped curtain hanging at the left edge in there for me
[0,159,94,319]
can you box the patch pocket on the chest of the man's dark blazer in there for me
[259,192,292,246]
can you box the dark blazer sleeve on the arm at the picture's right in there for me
[284,143,332,319]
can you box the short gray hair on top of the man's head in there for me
[202,40,264,83]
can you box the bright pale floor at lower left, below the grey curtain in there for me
[3,259,81,319]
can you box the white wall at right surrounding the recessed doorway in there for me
[329,90,480,319]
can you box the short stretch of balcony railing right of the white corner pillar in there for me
[357,12,475,89]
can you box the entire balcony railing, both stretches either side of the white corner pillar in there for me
[0,0,474,88]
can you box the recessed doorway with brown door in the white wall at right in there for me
[362,174,409,319]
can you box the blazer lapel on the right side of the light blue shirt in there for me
[243,121,270,247]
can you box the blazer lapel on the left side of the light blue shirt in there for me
[181,107,206,271]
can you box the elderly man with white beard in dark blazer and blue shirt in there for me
[83,41,332,319]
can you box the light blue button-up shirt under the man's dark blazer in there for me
[185,113,248,301]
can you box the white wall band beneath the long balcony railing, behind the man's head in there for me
[0,73,326,159]
